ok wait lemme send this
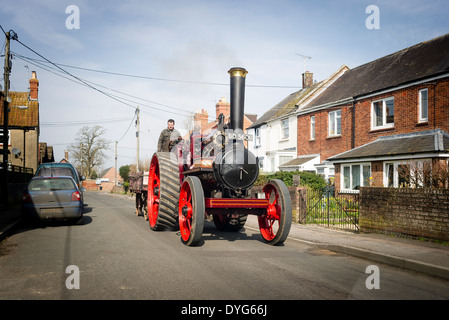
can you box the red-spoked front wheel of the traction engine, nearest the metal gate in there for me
[258,179,292,246]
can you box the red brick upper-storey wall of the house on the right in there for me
[297,78,449,161]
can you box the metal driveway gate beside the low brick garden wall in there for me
[299,187,359,232]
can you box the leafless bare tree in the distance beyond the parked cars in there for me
[69,126,111,178]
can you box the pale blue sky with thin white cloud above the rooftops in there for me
[0,0,449,169]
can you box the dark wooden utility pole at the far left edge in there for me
[2,31,11,206]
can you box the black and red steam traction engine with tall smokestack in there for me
[147,68,292,246]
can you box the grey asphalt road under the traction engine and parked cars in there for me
[0,192,449,301]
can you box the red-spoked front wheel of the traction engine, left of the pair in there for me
[178,176,205,246]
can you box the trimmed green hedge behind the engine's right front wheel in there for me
[254,171,326,190]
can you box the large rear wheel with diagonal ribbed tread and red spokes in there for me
[147,152,179,231]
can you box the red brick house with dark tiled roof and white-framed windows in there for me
[297,34,449,191]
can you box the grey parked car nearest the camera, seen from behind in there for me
[22,176,84,224]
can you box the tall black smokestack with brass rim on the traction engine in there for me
[228,67,248,130]
